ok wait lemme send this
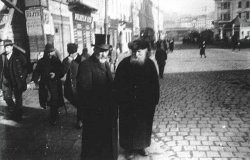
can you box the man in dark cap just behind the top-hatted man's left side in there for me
[63,43,82,129]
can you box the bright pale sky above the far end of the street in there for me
[159,0,214,15]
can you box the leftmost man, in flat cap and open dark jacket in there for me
[0,40,28,121]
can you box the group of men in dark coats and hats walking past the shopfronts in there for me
[0,39,164,160]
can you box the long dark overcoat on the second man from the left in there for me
[32,56,64,107]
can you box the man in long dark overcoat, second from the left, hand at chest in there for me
[30,44,64,125]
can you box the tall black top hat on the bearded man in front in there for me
[92,34,110,51]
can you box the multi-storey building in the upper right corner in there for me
[214,0,250,39]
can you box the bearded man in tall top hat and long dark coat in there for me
[77,36,117,160]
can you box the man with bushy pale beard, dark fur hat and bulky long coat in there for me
[114,40,159,159]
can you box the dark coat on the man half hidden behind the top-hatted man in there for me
[63,55,81,106]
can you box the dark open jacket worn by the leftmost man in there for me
[0,50,28,92]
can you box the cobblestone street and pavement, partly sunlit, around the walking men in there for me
[0,49,250,160]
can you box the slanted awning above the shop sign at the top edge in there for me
[68,0,97,12]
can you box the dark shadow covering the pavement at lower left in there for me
[0,102,81,160]
